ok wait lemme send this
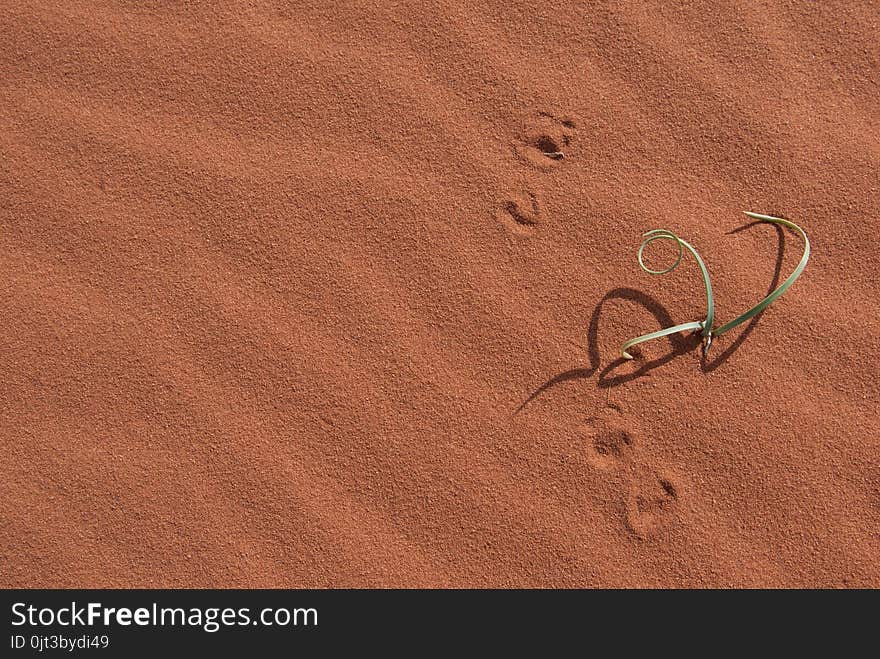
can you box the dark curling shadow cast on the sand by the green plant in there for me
[514,222,785,416]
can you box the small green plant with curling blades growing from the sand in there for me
[620,211,810,359]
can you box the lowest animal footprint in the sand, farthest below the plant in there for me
[626,470,681,540]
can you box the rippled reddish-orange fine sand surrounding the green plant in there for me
[0,0,880,587]
